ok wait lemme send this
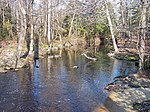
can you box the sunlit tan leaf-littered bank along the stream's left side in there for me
[0,38,85,72]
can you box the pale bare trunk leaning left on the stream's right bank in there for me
[105,1,118,52]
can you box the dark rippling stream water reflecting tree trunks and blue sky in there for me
[0,50,137,112]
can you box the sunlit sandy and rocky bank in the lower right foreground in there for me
[105,71,150,112]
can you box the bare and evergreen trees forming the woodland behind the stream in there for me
[0,0,150,68]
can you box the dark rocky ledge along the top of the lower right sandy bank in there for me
[105,74,150,91]
